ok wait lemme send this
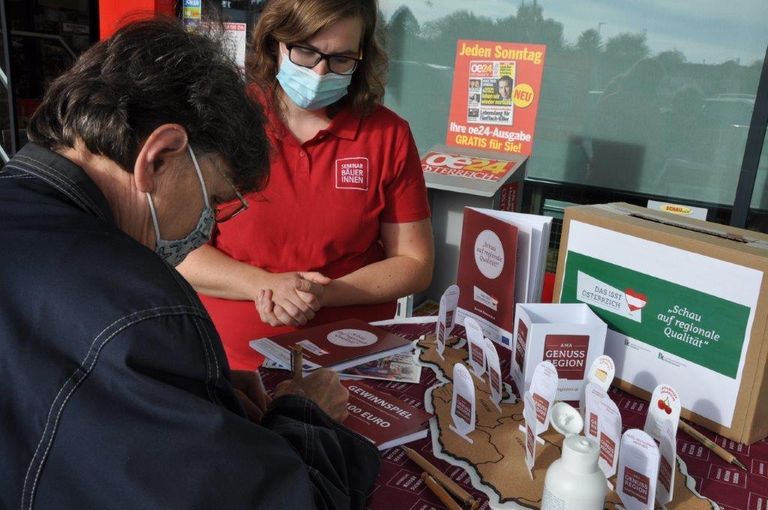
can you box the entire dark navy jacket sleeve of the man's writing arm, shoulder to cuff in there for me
[30,314,379,510]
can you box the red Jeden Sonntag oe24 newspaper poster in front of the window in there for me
[446,39,546,156]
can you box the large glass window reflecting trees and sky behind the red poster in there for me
[380,0,768,221]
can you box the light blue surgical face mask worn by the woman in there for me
[277,53,352,110]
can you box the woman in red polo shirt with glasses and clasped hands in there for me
[179,0,434,369]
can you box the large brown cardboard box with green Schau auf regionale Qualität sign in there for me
[554,203,768,443]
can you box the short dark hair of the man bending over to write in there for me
[27,17,269,191]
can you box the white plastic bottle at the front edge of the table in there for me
[541,435,608,510]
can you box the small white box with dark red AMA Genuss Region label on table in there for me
[510,303,606,402]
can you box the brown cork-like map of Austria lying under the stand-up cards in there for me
[418,334,718,510]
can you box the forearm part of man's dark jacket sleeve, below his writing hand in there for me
[262,395,379,509]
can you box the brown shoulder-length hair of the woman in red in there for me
[246,0,387,115]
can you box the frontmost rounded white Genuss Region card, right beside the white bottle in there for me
[616,429,659,510]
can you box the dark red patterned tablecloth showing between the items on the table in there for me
[264,319,768,510]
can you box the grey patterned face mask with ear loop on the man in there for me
[147,145,215,266]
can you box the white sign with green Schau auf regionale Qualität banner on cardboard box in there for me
[558,218,764,430]
